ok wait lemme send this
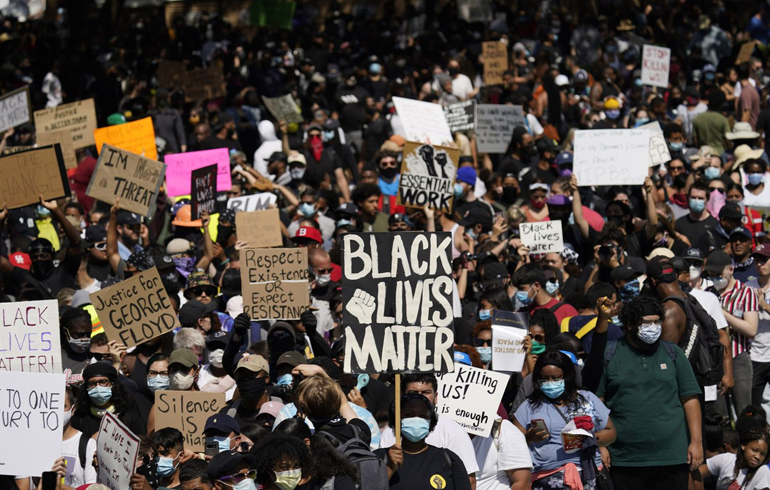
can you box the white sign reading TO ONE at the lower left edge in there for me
[0,374,66,476]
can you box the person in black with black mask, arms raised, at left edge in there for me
[0,196,80,299]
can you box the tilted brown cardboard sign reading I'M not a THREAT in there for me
[86,144,166,216]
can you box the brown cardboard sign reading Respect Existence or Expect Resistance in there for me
[242,249,310,320]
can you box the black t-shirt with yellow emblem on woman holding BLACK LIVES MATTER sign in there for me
[374,445,471,490]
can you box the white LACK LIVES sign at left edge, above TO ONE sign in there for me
[0,300,62,374]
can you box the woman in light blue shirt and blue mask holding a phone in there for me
[514,351,616,489]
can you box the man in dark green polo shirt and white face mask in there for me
[596,296,703,490]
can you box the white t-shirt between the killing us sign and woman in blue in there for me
[471,420,532,490]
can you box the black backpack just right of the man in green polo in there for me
[663,294,725,386]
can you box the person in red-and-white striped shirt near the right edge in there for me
[703,250,759,416]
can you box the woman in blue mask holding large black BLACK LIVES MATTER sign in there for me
[374,393,471,490]
